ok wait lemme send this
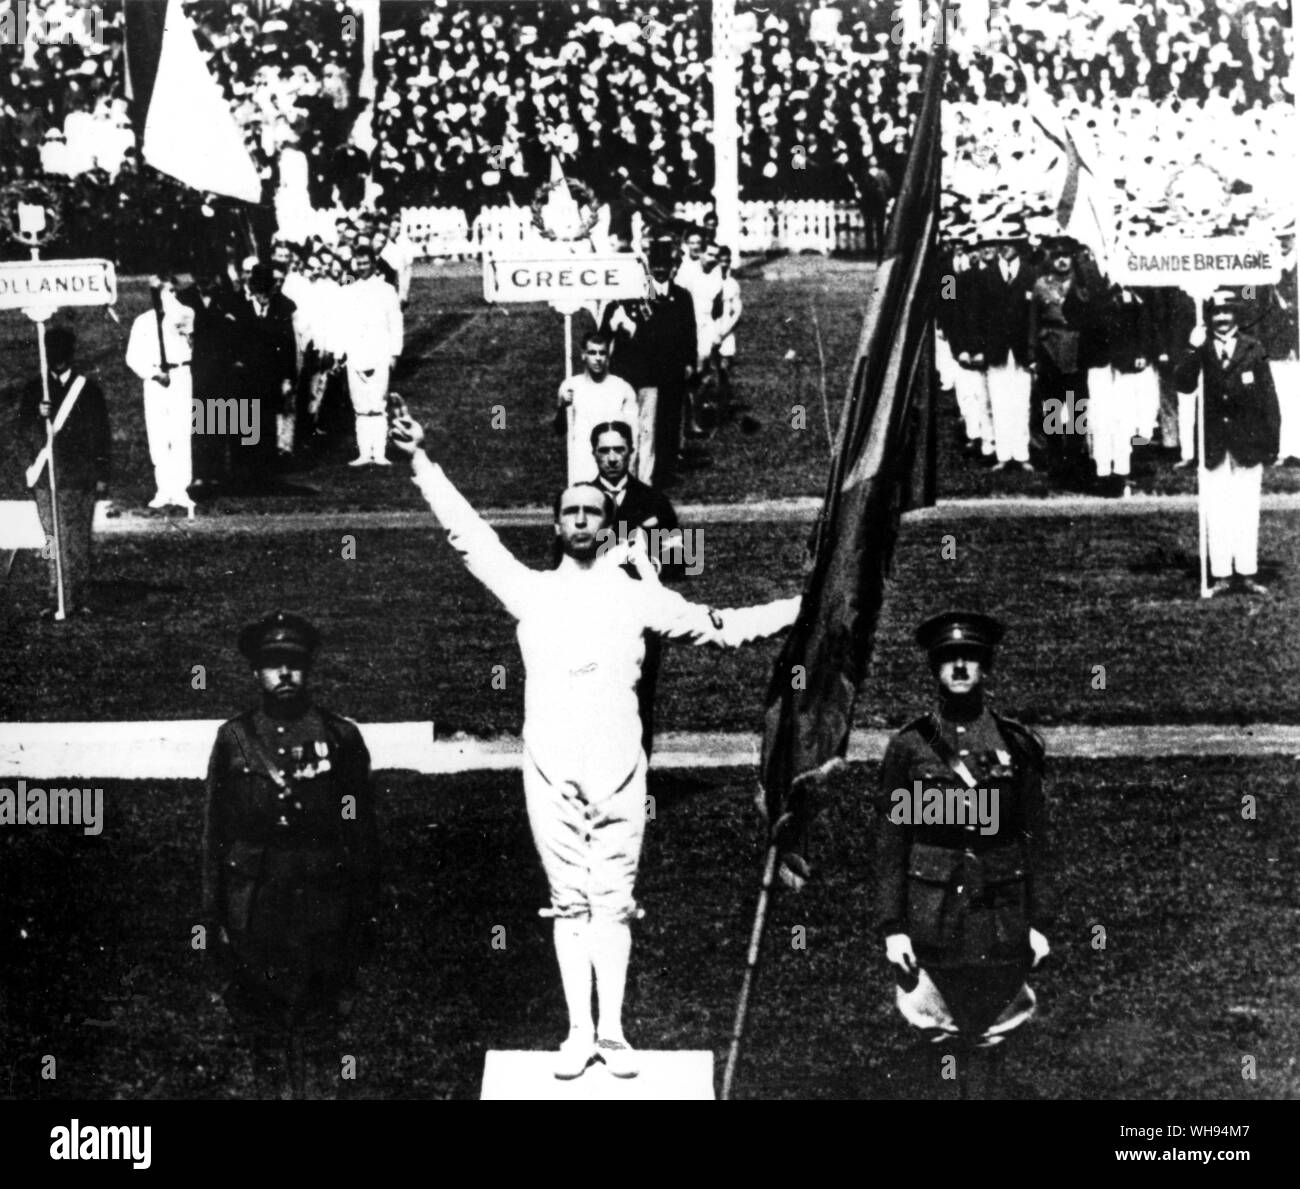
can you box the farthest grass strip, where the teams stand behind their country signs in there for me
[0,256,1300,512]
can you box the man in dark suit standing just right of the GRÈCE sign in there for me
[601,239,696,487]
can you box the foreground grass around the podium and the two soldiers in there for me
[0,760,1300,1099]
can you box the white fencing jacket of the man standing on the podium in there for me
[412,451,800,800]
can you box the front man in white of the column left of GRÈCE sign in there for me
[338,253,402,467]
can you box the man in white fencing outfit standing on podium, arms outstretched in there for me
[391,416,800,1077]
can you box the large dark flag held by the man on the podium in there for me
[761,44,946,852]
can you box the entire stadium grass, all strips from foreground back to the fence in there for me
[0,248,1300,1099]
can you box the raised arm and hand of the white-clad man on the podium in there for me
[390,415,536,619]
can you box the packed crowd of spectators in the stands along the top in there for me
[0,0,1291,253]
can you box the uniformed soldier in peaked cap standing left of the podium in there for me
[203,612,378,1097]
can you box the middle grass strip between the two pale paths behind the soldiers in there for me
[0,513,1300,734]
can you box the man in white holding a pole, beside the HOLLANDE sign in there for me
[126,277,194,509]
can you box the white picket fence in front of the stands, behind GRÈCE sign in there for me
[402,199,866,260]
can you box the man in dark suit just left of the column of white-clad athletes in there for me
[228,264,298,487]
